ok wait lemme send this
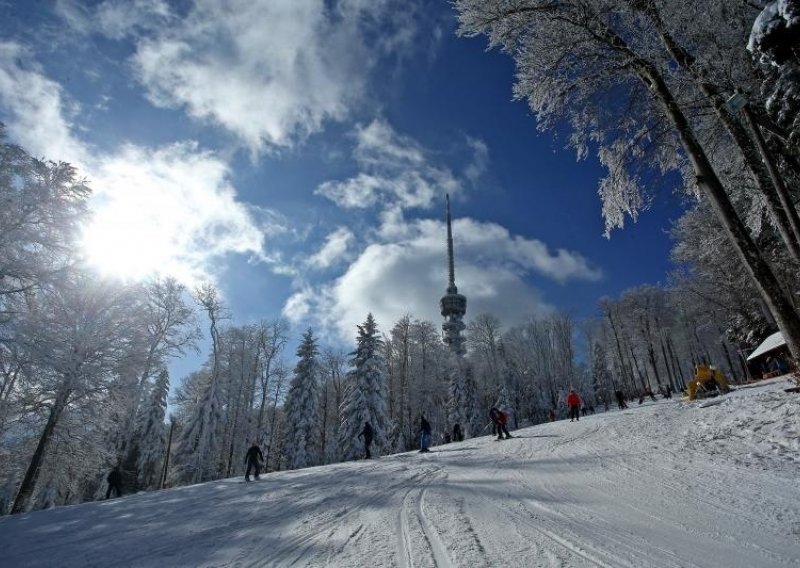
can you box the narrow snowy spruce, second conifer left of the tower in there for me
[283,329,321,469]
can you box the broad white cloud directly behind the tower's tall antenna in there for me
[284,217,601,341]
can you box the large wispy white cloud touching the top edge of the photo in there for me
[55,0,428,155]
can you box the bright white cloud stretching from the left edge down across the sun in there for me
[0,42,276,283]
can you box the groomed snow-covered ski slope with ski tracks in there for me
[0,379,800,568]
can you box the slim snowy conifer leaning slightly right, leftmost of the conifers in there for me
[136,369,169,489]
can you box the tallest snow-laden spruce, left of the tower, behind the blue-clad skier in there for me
[339,314,389,460]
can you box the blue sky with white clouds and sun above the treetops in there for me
[0,0,679,356]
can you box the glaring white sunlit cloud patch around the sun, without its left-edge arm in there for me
[84,143,272,282]
